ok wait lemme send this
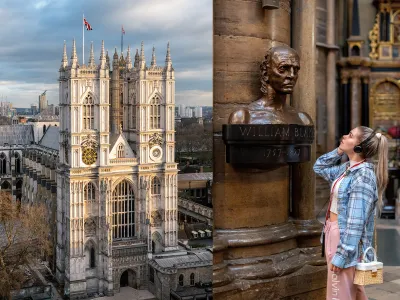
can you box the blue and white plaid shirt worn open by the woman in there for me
[314,149,378,268]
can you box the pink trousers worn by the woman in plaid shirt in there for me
[325,220,368,300]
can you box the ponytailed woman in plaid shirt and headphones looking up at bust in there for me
[314,126,388,300]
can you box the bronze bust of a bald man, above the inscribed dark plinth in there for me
[228,46,313,125]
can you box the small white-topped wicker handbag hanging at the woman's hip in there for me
[353,247,383,285]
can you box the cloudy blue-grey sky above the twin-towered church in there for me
[0,0,212,107]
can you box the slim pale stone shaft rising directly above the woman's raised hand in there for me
[326,0,337,151]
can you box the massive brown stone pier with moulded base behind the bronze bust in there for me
[213,0,326,300]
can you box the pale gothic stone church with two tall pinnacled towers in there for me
[5,41,211,299]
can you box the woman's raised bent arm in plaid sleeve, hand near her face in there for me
[314,148,343,183]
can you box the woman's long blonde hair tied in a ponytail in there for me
[357,126,389,209]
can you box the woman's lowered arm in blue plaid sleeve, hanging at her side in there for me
[331,169,376,268]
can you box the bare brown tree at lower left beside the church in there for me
[0,191,51,299]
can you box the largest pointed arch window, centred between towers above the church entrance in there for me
[112,180,135,240]
